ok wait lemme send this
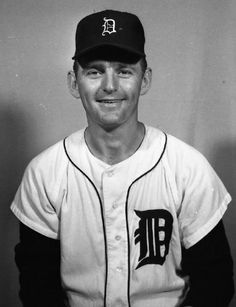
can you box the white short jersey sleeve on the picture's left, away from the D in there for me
[11,160,59,239]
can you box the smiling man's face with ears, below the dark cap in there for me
[72,53,151,129]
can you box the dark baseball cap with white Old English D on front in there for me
[72,10,145,60]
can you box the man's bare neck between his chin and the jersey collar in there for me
[85,122,145,165]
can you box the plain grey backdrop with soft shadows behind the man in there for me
[0,0,236,307]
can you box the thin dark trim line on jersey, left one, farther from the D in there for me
[63,138,108,307]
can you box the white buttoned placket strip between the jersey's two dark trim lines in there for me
[102,169,127,302]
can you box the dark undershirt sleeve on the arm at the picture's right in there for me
[182,221,234,307]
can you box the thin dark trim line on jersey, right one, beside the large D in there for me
[125,132,167,307]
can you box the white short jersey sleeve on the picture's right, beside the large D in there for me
[179,149,231,248]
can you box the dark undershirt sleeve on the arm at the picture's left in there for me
[15,223,67,307]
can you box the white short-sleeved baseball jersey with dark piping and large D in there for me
[11,126,231,307]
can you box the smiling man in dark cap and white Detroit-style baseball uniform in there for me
[11,10,234,307]
